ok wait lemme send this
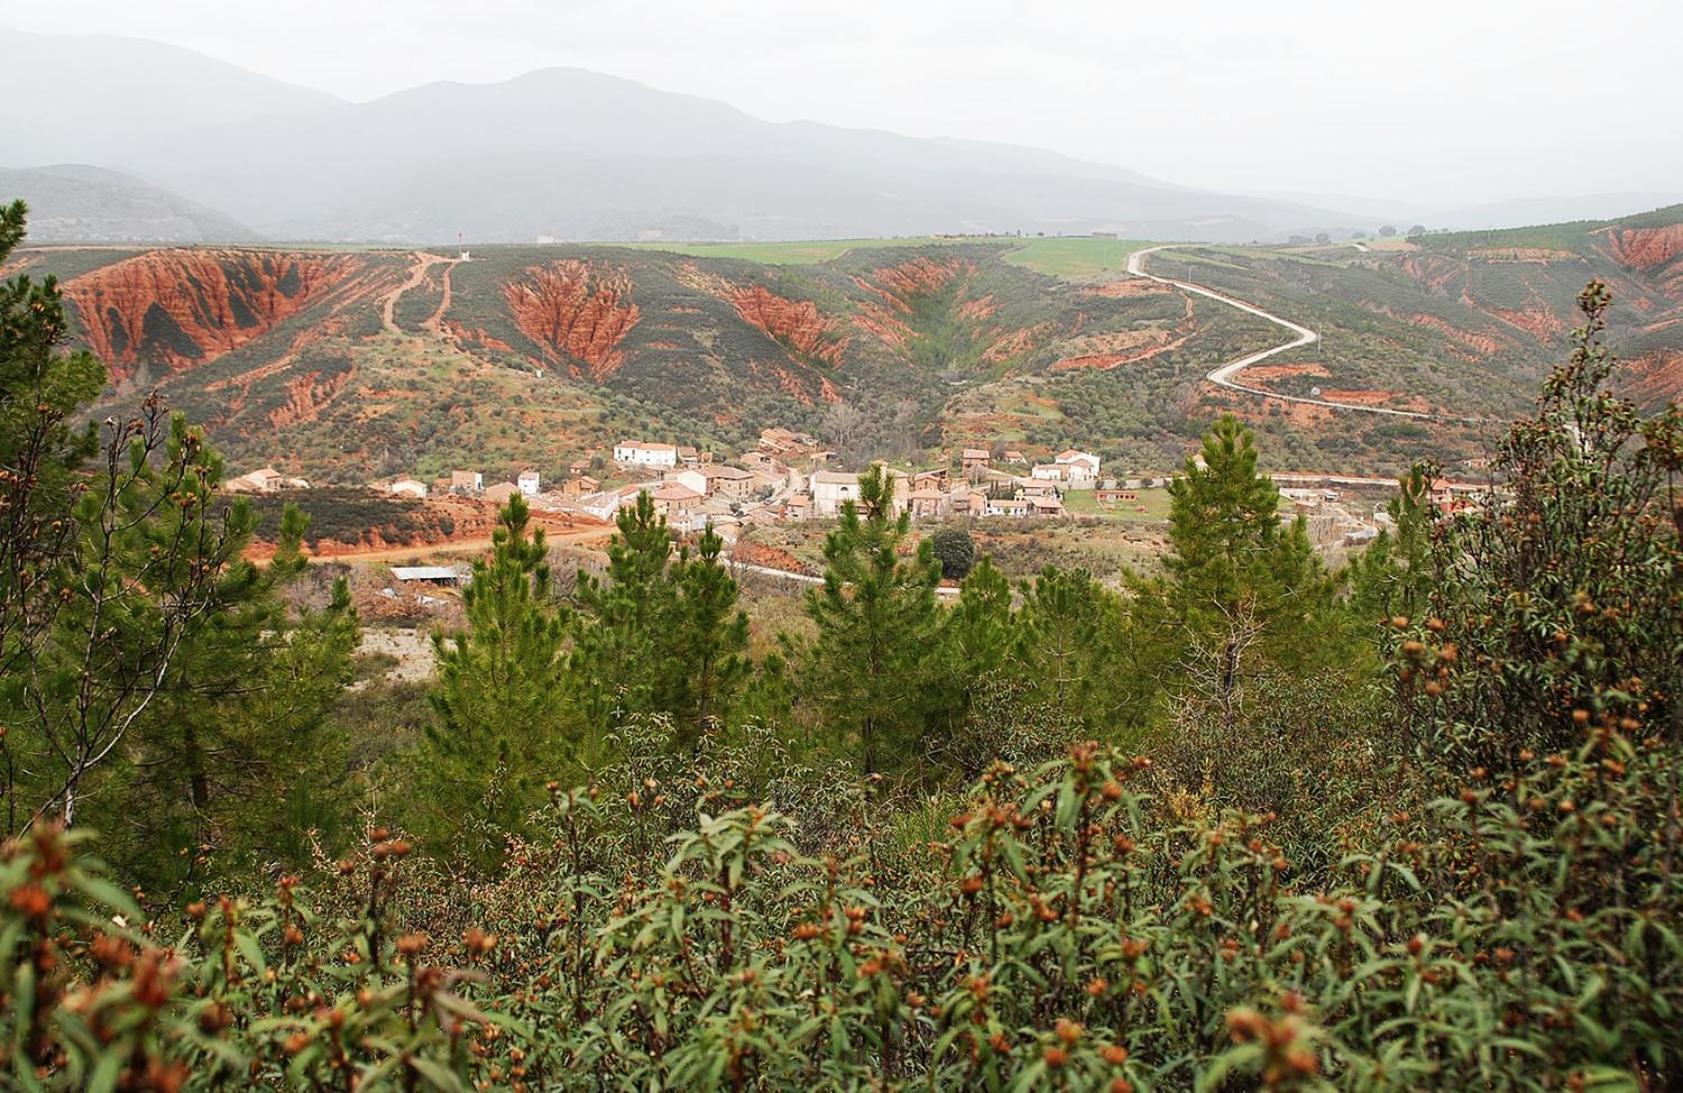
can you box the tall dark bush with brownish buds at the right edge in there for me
[1392,283,1683,770]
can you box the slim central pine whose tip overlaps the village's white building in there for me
[806,467,941,775]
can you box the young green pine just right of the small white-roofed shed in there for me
[417,493,569,862]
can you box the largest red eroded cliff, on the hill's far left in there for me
[64,248,364,381]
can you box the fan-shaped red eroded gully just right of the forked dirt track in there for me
[503,258,640,382]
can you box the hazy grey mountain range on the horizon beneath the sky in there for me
[0,30,1683,244]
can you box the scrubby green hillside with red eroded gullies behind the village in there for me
[6,209,1683,482]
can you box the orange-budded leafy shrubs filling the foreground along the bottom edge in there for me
[0,726,1683,1090]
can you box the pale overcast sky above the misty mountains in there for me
[0,0,1683,204]
